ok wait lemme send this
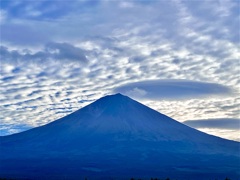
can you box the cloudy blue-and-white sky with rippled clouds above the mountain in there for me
[0,0,240,141]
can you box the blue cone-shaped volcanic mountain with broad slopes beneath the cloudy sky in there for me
[0,94,240,180]
